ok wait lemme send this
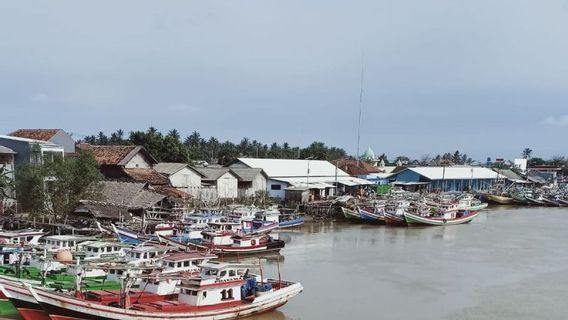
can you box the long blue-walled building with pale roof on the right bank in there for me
[392,166,498,192]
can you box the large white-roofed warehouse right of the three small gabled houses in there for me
[229,158,371,199]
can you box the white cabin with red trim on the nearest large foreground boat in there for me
[178,262,249,307]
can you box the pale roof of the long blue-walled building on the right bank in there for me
[407,167,497,180]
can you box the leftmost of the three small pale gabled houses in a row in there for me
[154,162,203,193]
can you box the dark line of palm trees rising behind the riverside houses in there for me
[82,127,348,165]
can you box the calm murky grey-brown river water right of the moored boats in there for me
[250,207,568,320]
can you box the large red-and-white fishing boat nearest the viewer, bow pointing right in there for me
[28,262,303,320]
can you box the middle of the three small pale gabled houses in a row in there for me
[193,167,239,199]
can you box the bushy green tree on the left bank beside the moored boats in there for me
[16,151,103,221]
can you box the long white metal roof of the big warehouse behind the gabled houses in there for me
[233,158,349,178]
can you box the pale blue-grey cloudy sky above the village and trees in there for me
[0,0,568,160]
